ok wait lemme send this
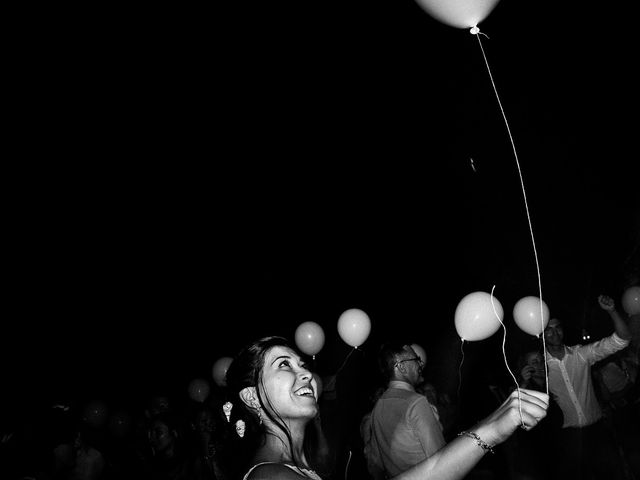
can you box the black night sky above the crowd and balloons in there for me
[3,0,640,416]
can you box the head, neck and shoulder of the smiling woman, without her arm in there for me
[227,337,320,479]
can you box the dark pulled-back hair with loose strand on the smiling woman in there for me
[226,336,308,474]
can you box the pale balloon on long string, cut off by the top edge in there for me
[416,0,498,28]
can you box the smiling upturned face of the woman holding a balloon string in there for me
[262,346,318,419]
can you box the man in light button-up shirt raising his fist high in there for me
[544,295,631,480]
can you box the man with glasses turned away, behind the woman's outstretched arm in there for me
[365,342,445,479]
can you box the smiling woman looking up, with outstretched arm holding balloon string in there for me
[226,337,548,480]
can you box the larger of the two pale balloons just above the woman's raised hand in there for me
[455,292,504,341]
